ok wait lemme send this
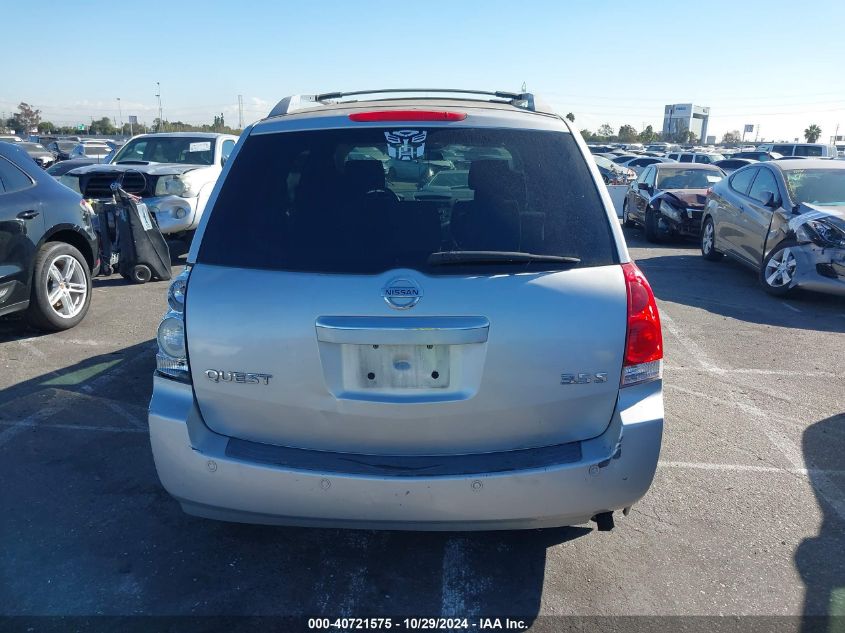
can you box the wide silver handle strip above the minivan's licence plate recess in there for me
[316,316,490,345]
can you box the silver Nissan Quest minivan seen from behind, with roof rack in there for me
[149,91,663,530]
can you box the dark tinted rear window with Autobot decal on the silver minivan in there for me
[197,127,618,274]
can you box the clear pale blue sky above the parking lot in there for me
[6,0,845,141]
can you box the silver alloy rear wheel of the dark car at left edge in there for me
[27,242,91,332]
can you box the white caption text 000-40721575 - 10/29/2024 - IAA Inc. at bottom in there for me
[308,618,530,631]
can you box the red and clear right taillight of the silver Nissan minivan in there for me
[621,263,663,387]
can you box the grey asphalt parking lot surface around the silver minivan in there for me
[0,229,845,630]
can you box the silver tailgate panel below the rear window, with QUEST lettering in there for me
[185,264,627,455]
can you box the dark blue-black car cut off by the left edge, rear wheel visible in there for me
[0,143,99,331]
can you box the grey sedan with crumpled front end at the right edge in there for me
[701,159,845,296]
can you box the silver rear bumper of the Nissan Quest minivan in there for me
[149,376,663,530]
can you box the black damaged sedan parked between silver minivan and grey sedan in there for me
[622,163,725,242]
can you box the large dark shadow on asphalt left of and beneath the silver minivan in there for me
[0,341,591,621]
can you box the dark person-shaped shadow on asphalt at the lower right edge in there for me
[795,414,845,633]
